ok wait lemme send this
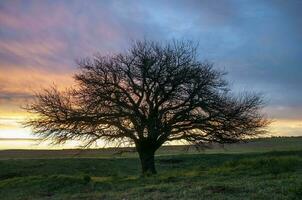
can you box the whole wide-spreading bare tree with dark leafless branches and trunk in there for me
[25,41,268,173]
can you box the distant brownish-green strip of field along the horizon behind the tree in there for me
[0,137,302,159]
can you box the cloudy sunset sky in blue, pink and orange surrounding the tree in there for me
[0,0,302,148]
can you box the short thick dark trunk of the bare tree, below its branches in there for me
[138,149,156,174]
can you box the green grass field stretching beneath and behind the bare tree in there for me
[0,137,302,200]
